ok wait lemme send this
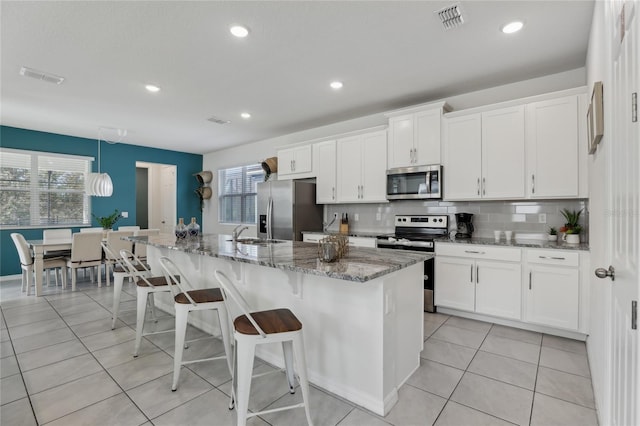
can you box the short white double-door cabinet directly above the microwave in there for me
[387,103,448,169]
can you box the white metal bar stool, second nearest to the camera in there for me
[160,257,233,391]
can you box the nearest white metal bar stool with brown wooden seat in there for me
[215,270,313,426]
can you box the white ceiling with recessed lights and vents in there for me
[0,0,594,153]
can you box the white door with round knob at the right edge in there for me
[595,1,640,425]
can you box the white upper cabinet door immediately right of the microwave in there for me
[444,114,482,200]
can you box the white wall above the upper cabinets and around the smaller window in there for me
[202,68,586,235]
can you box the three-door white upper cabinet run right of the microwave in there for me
[443,89,588,200]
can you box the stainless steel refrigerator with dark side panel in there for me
[258,180,323,241]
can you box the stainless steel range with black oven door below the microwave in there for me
[378,215,449,312]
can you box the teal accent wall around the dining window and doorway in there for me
[0,126,202,276]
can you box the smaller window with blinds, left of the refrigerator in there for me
[218,164,264,224]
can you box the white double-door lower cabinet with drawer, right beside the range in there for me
[435,243,522,320]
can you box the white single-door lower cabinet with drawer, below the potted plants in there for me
[525,249,580,330]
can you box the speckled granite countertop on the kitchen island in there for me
[127,234,433,282]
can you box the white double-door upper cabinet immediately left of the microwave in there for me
[336,130,387,203]
